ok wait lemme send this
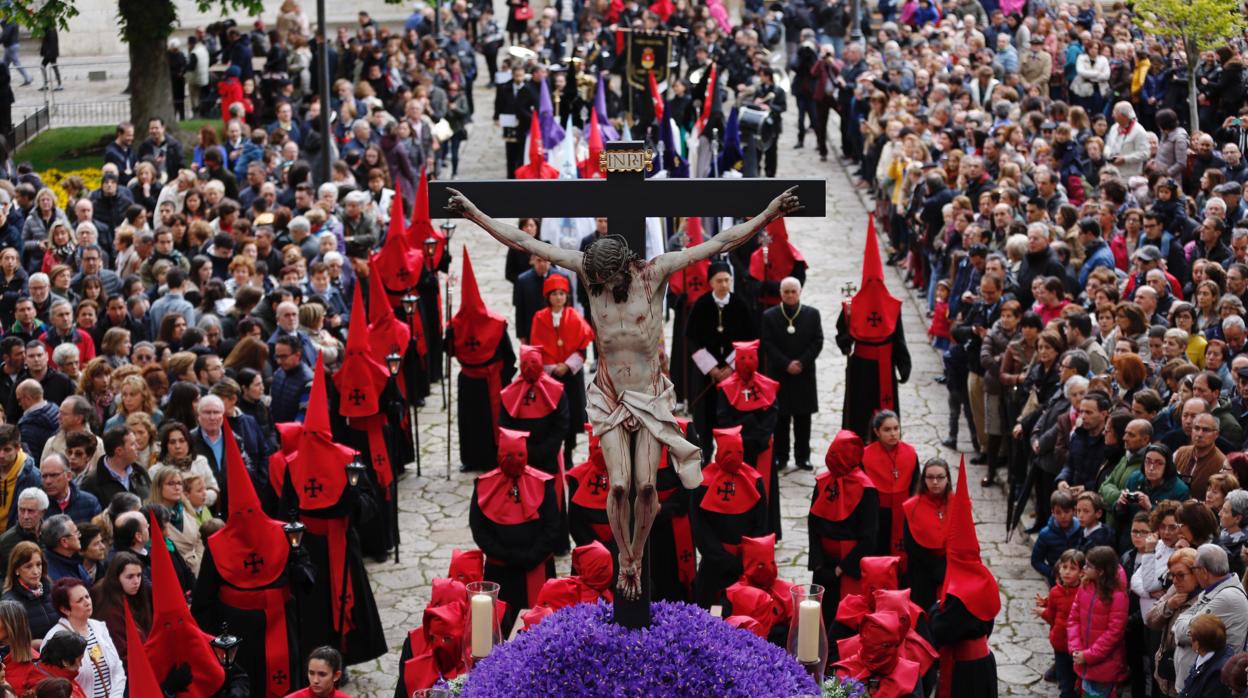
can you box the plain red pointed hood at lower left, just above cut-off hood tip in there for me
[144,516,226,698]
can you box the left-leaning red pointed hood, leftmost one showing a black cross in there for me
[208,421,291,589]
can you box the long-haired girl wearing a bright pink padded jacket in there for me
[1066,546,1127,696]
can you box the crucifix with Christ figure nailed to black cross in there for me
[431,144,824,627]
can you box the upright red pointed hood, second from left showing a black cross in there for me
[290,353,356,509]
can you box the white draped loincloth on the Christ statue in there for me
[585,376,701,489]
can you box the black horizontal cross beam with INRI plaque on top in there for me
[429,141,826,256]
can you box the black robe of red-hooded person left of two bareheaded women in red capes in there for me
[806,487,880,628]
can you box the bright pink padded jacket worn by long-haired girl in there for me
[1066,582,1127,682]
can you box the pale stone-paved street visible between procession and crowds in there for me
[347,83,1052,697]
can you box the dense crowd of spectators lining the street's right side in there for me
[838,0,1248,696]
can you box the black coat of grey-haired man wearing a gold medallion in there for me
[759,306,824,415]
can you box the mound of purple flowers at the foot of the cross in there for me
[463,602,821,698]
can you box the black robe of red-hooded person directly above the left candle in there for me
[468,479,559,634]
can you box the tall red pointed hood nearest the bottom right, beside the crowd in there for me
[938,456,1001,621]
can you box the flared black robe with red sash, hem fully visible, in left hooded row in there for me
[281,476,389,664]
